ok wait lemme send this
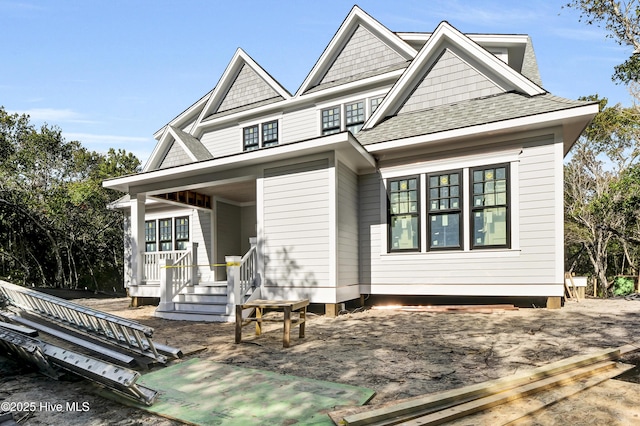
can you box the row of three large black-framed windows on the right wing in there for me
[387,164,511,252]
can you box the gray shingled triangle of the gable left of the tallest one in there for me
[216,65,280,112]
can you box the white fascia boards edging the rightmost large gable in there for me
[363,21,546,130]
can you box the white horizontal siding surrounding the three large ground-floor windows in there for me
[360,141,563,296]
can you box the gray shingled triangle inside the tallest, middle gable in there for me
[320,25,406,84]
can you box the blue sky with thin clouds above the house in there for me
[0,0,631,163]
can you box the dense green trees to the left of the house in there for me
[0,107,140,289]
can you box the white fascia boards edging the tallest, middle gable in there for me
[294,6,418,97]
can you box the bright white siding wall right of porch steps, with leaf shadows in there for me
[262,159,335,303]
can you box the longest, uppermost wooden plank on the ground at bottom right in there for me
[343,348,620,426]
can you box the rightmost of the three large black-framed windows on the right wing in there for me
[470,164,511,248]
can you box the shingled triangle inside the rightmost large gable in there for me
[398,49,503,114]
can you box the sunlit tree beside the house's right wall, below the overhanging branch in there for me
[565,96,640,293]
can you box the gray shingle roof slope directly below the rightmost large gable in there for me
[356,92,592,145]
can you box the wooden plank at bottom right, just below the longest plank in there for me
[403,361,616,426]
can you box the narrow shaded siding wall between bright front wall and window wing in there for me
[337,163,359,287]
